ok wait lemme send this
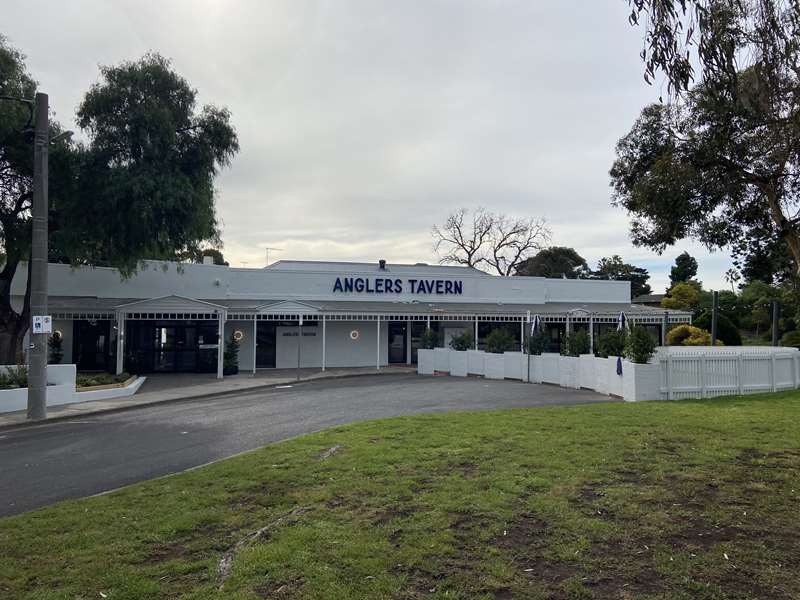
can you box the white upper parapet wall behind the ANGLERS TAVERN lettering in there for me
[6,261,630,304]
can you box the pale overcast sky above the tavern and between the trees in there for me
[0,0,731,292]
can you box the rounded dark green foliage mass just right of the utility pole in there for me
[67,54,239,273]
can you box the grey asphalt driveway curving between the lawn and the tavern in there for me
[0,374,609,516]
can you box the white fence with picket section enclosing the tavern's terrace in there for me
[417,346,800,401]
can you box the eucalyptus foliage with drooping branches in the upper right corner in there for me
[611,0,800,274]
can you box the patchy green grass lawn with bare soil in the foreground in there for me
[0,392,800,600]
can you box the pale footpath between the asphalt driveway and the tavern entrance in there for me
[0,366,416,430]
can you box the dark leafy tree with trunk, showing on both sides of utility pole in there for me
[0,38,238,364]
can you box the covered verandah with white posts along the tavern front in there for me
[48,295,691,378]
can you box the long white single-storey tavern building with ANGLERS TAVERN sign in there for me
[12,260,690,377]
